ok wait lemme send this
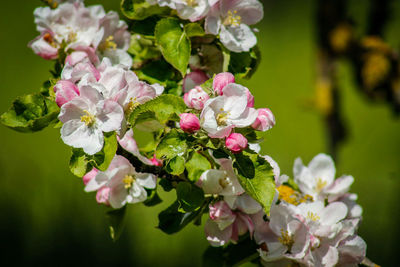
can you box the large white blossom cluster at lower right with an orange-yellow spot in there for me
[252,154,366,266]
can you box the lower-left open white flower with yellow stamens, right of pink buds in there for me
[85,155,156,209]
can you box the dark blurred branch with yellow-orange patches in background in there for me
[315,0,400,158]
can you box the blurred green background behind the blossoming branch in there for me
[0,0,400,266]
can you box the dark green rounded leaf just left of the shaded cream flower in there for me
[176,182,204,212]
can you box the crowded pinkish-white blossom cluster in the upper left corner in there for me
[29,0,132,67]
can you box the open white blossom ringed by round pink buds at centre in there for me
[180,72,275,153]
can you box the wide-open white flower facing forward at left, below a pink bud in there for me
[58,86,124,155]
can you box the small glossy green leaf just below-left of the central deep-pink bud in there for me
[155,129,187,159]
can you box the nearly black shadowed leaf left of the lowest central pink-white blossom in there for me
[158,201,203,234]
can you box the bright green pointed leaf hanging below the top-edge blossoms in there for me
[155,18,191,77]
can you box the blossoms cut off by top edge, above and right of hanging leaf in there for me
[147,0,264,52]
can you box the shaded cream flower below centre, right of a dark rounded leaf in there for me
[197,159,244,196]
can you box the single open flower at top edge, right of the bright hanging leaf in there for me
[205,0,264,52]
